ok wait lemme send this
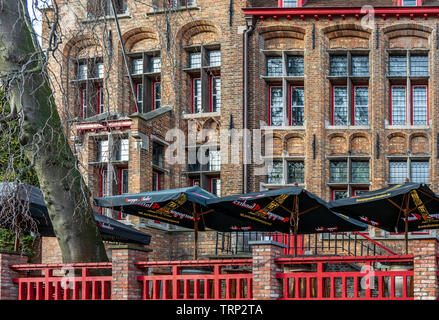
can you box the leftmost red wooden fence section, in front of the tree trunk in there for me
[11,263,111,300]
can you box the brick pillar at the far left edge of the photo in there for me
[0,251,28,300]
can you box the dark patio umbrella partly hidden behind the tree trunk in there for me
[0,182,151,245]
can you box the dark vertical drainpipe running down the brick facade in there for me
[242,17,255,193]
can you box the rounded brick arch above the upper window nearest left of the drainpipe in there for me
[177,20,221,46]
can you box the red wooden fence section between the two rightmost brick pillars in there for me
[276,255,413,300]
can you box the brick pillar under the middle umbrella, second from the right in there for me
[249,241,286,300]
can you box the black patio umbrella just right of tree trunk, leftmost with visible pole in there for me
[94,187,222,260]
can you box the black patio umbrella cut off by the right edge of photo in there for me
[329,182,439,251]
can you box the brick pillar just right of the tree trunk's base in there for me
[109,245,152,300]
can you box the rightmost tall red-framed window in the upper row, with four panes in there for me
[388,50,429,126]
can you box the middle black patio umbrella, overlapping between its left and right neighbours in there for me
[207,186,367,256]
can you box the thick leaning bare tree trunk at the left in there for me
[0,0,108,263]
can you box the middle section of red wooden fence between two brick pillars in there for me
[136,259,253,300]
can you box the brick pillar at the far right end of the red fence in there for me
[411,237,439,300]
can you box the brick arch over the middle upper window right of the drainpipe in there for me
[322,24,372,49]
